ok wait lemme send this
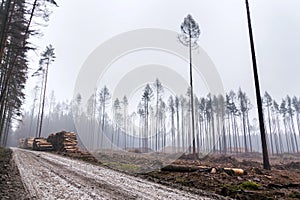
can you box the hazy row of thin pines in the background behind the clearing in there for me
[10,79,300,155]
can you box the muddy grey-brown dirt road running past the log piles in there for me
[13,148,211,200]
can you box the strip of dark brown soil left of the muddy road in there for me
[0,147,29,200]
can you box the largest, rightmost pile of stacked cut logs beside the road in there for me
[47,131,78,153]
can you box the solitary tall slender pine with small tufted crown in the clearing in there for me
[179,14,200,154]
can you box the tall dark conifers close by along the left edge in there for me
[0,0,56,144]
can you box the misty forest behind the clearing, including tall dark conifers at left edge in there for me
[0,0,300,155]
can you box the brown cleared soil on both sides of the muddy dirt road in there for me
[0,146,300,200]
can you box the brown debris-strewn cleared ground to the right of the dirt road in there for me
[89,152,300,200]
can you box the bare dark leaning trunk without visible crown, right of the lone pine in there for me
[246,0,271,170]
